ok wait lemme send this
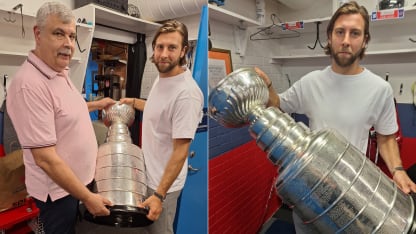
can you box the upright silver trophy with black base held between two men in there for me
[86,102,152,227]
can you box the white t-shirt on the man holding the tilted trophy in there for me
[279,66,398,153]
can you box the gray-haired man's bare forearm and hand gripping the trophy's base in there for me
[31,146,112,216]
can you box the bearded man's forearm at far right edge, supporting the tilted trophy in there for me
[377,133,416,193]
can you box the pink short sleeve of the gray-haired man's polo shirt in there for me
[8,89,56,148]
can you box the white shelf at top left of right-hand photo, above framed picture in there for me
[208,4,260,27]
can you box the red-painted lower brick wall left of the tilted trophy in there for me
[208,141,281,234]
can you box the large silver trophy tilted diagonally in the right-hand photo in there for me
[209,68,416,233]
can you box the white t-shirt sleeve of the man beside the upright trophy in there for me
[172,94,202,139]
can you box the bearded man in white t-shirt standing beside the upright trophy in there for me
[120,20,203,234]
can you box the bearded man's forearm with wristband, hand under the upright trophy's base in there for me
[142,139,191,220]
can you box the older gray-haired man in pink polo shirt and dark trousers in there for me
[6,2,115,233]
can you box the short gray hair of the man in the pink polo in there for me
[36,2,75,28]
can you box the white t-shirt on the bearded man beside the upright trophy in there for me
[142,66,204,193]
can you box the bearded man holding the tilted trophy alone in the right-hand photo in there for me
[257,1,416,234]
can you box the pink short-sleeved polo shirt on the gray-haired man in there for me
[7,52,98,201]
